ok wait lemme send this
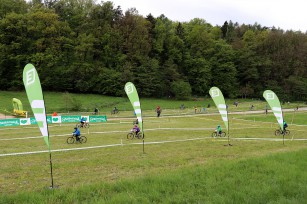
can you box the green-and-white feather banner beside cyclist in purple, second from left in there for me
[125,82,144,134]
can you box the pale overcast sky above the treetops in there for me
[109,0,307,32]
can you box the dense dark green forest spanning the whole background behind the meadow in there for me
[0,0,307,101]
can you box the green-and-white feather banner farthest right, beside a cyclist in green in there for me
[263,90,284,130]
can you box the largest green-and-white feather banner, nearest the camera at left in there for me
[23,64,50,147]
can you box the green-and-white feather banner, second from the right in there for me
[209,87,229,131]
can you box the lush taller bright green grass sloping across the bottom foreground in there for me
[0,149,307,203]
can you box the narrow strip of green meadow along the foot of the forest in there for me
[0,91,307,116]
